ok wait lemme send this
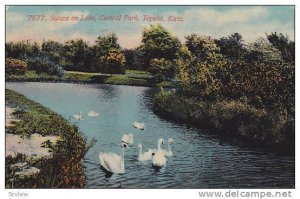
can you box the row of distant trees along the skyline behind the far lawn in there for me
[5,25,295,79]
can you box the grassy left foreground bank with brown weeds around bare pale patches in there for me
[5,89,87,188]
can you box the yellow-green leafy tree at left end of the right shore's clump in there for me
[178,34,229,100]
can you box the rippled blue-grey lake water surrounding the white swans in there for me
[6,83,295,188]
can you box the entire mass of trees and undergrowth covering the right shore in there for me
[155,33,295,152]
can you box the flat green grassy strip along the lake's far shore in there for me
[5,70,173,87]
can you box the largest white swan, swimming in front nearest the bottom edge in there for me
[99,143,127,173]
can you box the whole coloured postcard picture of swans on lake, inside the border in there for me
[5,5,295,191]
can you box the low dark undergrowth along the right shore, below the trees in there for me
[155,91,295,153]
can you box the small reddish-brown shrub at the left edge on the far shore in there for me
[5,58,27,75]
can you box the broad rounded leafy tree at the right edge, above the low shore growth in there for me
[228,39,295,110]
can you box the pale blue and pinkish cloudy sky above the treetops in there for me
[6,6,294,48]
